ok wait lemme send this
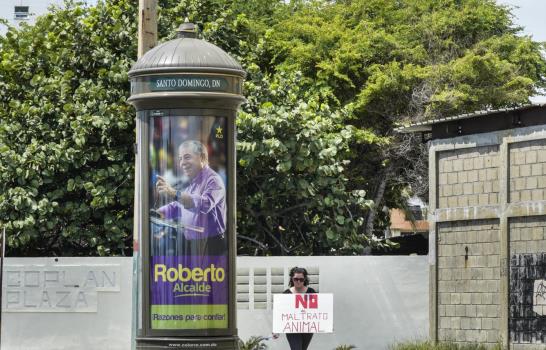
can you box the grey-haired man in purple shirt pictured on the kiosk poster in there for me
[156,140,227,255]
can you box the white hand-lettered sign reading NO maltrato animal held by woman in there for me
[273,293,334,333]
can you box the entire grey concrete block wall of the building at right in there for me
[428,125,546,350]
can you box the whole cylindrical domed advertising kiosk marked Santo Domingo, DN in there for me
[129,23,245,350]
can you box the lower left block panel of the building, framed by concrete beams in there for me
[438,220,500,345]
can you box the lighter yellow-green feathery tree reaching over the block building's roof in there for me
[266,0,546,234]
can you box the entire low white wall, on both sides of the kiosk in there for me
[1,256,428,350]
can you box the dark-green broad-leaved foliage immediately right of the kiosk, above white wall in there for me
[237,69,370,255]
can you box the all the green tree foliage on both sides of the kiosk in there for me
[0,0,546,255]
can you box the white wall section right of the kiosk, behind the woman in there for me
[237,256,428,350]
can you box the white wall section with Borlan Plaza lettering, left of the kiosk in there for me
[1,258,132,350]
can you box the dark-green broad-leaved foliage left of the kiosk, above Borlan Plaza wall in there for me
[0,1,136,256]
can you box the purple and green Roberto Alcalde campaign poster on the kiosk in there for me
[149,115,229,330]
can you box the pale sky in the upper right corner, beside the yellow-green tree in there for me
[497,0,546,103]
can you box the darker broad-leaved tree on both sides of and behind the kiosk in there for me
[0,1,367,256]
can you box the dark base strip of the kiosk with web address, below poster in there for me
[136,336,239,350]
